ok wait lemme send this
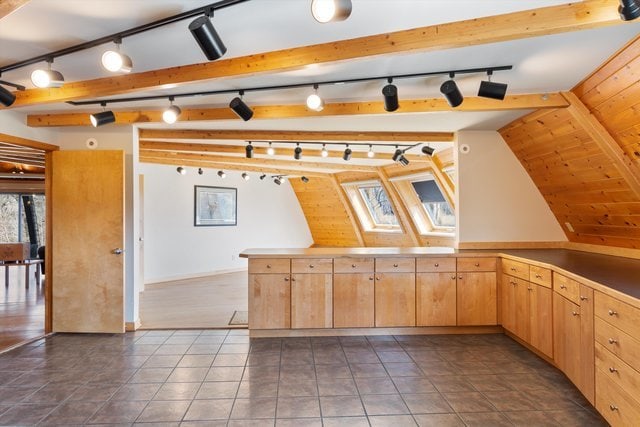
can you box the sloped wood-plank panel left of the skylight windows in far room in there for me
[290,176,362,247]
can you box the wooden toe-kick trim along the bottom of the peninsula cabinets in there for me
[249,326,504,338]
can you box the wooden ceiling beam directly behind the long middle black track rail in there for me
[27,93,568,127]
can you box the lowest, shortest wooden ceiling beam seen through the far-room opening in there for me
[140,150,375,172]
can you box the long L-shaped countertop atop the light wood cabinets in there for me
[240,247,640,299]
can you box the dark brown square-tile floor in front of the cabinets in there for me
[0,330,606,427]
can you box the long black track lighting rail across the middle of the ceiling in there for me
[67,65,513,106]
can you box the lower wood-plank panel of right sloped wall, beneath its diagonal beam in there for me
[500,109,640,248]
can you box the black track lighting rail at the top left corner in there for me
[0,0,249,74]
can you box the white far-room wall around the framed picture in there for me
[139,164,313,283]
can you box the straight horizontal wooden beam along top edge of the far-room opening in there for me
[139,129,454,142]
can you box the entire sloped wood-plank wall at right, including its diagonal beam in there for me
[500,37,640,249]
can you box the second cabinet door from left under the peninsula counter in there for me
[291,274,333,329]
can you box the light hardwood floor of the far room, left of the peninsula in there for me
[140,271,248,329]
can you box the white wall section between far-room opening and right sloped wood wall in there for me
[455,131,567,242]
